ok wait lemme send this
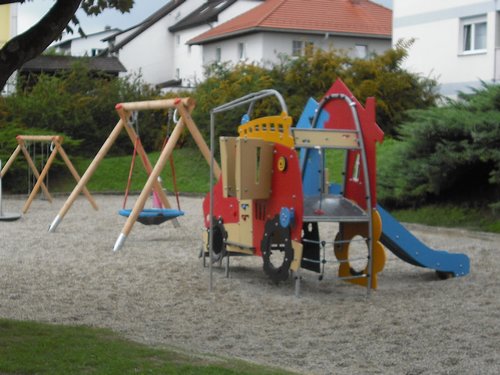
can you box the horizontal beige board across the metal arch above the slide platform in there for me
[293,128,359,148]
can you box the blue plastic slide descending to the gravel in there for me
[377,205,470,278]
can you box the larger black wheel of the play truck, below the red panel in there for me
[260,215,294,283]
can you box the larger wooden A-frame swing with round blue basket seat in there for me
[49,98,220,251]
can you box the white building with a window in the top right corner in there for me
[393,0,500,97]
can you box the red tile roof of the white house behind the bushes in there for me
[188,0,392,44]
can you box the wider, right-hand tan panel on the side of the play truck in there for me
[235,138,274,199]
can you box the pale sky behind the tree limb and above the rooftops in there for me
[17,0,392,39]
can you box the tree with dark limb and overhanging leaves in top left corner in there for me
[0,0,134,90]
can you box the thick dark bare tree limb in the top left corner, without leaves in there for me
[0,0,82,91]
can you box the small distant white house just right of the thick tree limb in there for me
[52,26,121,57]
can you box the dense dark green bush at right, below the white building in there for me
[379,84,500,209]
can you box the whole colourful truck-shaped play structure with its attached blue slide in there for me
[203,81,469,294]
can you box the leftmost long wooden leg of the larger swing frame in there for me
[49,119,124,232]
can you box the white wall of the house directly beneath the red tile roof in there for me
[203,32,391,64]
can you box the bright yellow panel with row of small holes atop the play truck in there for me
[238,113,293,147]
